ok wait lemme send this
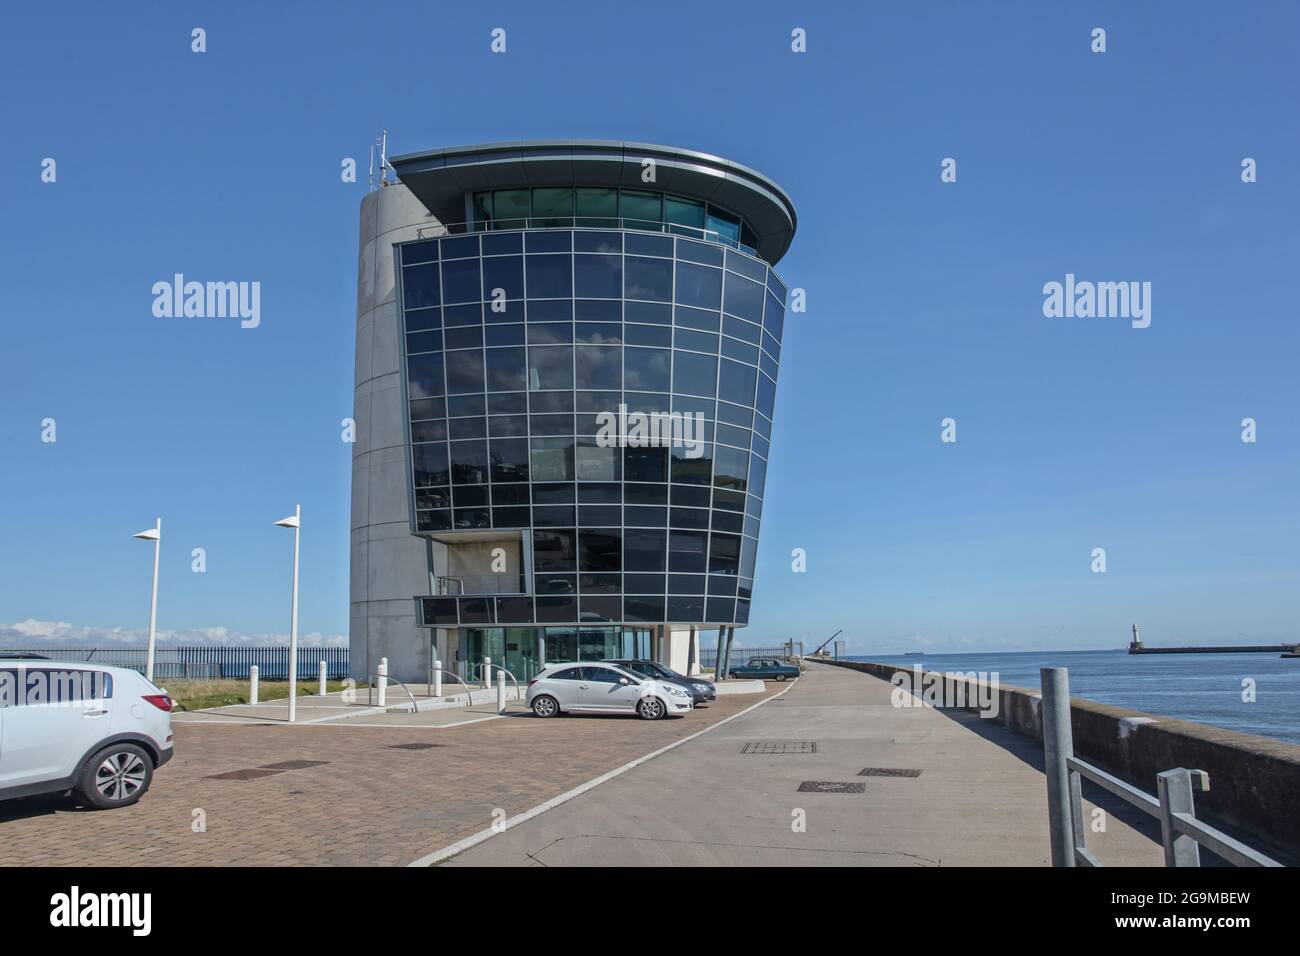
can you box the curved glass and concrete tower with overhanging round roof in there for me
[351,140,796,682]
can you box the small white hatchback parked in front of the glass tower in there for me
[528,662,693,721]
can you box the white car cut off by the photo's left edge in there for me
[0,657,173,810]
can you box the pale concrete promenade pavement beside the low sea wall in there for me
[442,665,1162,866]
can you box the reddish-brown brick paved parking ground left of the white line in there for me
[0,684,780,866]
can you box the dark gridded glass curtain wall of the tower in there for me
[400,227,787,632]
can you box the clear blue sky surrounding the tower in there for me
[0,3,1300,653]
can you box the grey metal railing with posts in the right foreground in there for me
[1040,667,1282,866]
